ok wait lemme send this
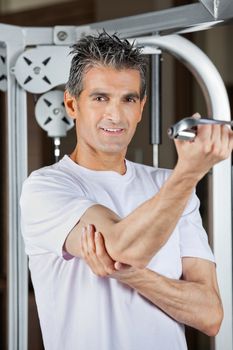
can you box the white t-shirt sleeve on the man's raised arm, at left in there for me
[20,171,96,259]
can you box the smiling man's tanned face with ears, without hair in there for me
[64,66,145,153]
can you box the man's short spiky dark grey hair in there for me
[66,31,147,99]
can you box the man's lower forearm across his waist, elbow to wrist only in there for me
[115,269,222,336]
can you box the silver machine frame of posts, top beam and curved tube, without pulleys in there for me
[0,0,233,350]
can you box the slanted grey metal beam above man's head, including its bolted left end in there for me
[54,0,233,45]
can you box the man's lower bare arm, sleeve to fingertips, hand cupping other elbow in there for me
[82,225,223,336]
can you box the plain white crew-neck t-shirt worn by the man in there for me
[20,156,214,350]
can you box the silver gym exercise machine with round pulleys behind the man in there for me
[0,0,233,350]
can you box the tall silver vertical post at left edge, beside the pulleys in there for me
[0,26,28,350]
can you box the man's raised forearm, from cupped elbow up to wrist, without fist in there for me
[107,165,197,267]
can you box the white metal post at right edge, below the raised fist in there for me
[211,159,233,350]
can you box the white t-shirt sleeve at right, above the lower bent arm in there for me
[178,193,215,262]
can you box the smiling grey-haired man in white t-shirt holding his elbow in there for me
[21,32,233,350]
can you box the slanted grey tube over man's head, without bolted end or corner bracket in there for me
[76,0,224,38]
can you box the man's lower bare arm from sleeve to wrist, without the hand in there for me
[117,258,223,336]
